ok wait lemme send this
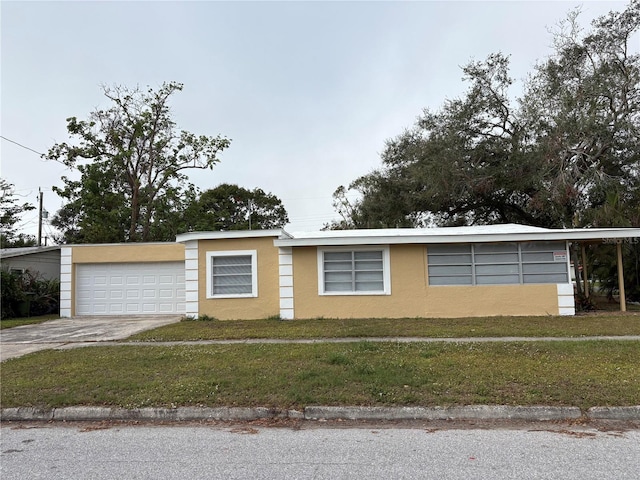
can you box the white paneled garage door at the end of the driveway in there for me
[76,262,185,315]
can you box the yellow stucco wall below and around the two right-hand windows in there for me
[293,245,558,318]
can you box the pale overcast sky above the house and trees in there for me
[0,0,627,244]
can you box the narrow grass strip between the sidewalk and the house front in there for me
[128,314,640,341]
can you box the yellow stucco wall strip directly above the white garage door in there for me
[71,243,184,263]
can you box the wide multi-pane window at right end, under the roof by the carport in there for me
[427,242,568,285]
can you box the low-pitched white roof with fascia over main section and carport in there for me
[274,224,640,247]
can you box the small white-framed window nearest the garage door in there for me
[207,250,258,298]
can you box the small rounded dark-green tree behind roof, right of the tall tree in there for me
[186,183,289,231]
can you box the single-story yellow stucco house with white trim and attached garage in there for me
[61,224,640,320]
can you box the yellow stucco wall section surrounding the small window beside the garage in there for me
[198,237,280,320]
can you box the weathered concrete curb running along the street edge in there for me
[0,405,640,422]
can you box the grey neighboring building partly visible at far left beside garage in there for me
[0,245,60,280]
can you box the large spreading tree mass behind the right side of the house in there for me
[327,0,640,228]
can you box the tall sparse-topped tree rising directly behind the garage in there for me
[47,82,230,243]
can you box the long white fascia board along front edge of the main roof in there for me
[274,227,640,247]
